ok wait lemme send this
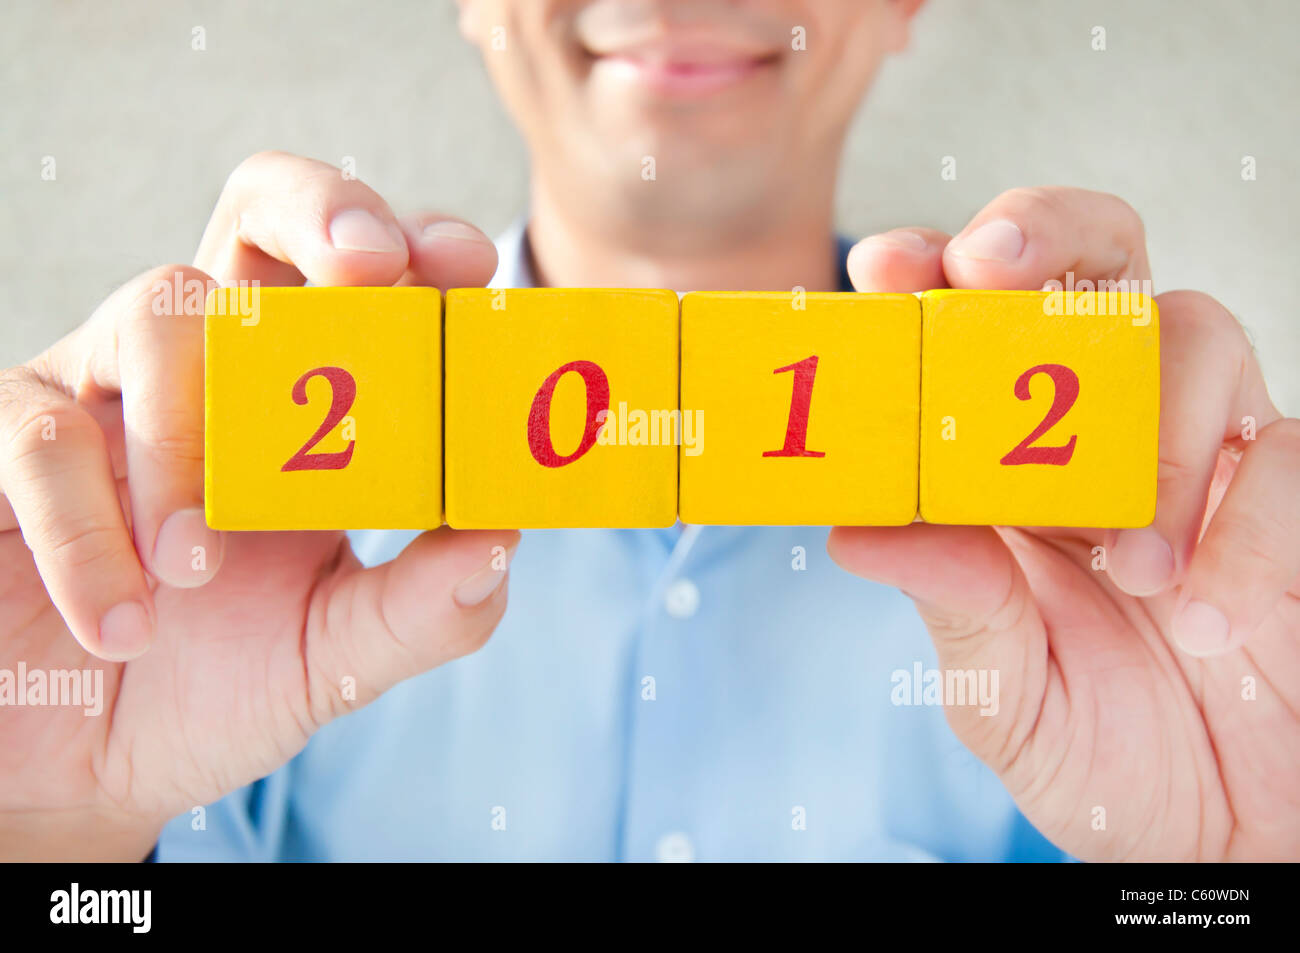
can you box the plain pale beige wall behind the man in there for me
[0,0,1300,415]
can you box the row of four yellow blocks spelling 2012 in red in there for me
[205,287,1160,530]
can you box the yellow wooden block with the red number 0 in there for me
[446,289,677,529]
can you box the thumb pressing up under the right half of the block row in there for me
[827,523,1048,771]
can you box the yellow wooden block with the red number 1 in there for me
[681,293,920,525]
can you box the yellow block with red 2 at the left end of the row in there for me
[204,287,442,529]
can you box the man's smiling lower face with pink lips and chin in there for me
[460,0,919,245]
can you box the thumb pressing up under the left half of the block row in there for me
[307,527,519,724]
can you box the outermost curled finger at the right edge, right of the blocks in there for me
[1173,417,1300,657]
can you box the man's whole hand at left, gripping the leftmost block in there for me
[0,153,519,859]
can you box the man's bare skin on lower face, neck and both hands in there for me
[0,0,1300,861]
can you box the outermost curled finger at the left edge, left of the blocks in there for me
[0,368,153,660]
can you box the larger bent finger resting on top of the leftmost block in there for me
[195,152,408,286]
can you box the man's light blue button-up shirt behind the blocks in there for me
[157,226,1066,861]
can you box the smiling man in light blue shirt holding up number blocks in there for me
[0,0,1300,859]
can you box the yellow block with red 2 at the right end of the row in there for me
[920,291,1160,528]
